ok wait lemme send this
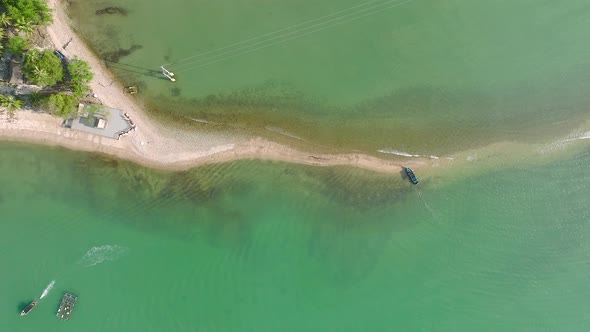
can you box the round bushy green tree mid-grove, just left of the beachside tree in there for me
[23,50,64,86]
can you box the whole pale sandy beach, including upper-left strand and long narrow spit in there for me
[0,0,428,173]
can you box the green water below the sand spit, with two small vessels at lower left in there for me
[0,144,590,331]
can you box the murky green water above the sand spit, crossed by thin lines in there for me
[69,0,590,155]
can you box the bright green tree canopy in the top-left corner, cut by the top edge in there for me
[0,0,52,28]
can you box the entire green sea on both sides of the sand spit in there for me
[0,0,590,332]
